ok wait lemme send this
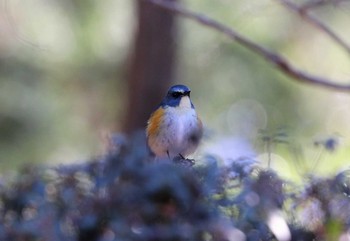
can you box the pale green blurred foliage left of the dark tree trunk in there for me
[0,0,132,169]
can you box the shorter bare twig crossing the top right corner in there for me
[278,0,350,54]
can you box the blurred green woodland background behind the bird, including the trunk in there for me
[0,0,350,177]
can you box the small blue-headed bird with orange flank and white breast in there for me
[146,85,203,160]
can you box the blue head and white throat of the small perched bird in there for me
[161,85,194,108]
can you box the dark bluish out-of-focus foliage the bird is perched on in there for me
[0,135,350,241]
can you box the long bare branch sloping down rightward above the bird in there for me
[142,0,350,91]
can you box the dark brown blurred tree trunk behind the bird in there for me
[124,0,177,134]
